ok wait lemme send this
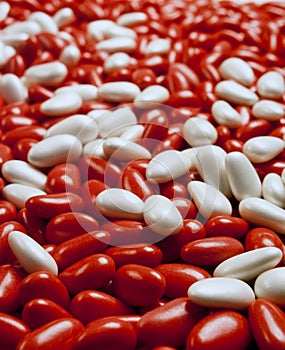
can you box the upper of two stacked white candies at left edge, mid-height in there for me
[2,159,47,190]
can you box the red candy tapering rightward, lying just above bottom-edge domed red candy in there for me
[69,290,134,324]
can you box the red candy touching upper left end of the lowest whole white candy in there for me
[155,263,211,299]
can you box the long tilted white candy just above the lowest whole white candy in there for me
[213,247,283,281]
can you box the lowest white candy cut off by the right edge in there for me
[254,267,285,307]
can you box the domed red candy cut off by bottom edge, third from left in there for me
[73,316,137,350]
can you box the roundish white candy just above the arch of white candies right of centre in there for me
[183,117,218,147]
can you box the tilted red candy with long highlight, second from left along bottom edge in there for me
[17,318,84,350]
